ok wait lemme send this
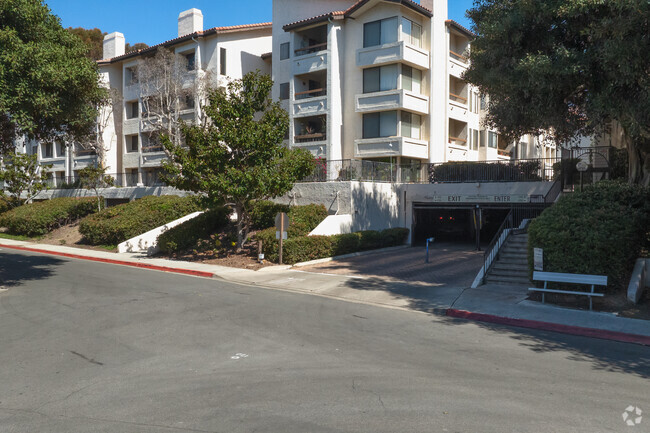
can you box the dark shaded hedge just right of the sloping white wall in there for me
[158,207,230,254]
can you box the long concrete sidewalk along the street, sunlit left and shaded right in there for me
[0,239,650,345]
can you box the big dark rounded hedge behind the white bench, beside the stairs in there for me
[528,181,650,289]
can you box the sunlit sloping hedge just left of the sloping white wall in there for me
[79,196,202,245]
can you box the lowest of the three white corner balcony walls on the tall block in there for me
[354,137,429,159]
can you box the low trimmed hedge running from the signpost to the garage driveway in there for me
[255,228,409,264]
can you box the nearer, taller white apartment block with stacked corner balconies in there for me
[272,0,540,180]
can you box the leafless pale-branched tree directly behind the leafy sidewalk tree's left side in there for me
[136,48,211,148]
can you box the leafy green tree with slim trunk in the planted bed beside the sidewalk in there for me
[163,72,314,249]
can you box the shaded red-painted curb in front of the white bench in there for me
[446,308,650,346]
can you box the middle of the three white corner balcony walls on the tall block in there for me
[355,89,429,114]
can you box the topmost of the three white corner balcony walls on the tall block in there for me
[357,41,429,70]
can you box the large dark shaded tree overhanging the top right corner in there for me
[465,0,650,185]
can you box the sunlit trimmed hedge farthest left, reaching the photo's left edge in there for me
[0,197,97,236]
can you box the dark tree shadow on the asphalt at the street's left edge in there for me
[0,252,63,287]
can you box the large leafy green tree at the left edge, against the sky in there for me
[0,0,106,154]
